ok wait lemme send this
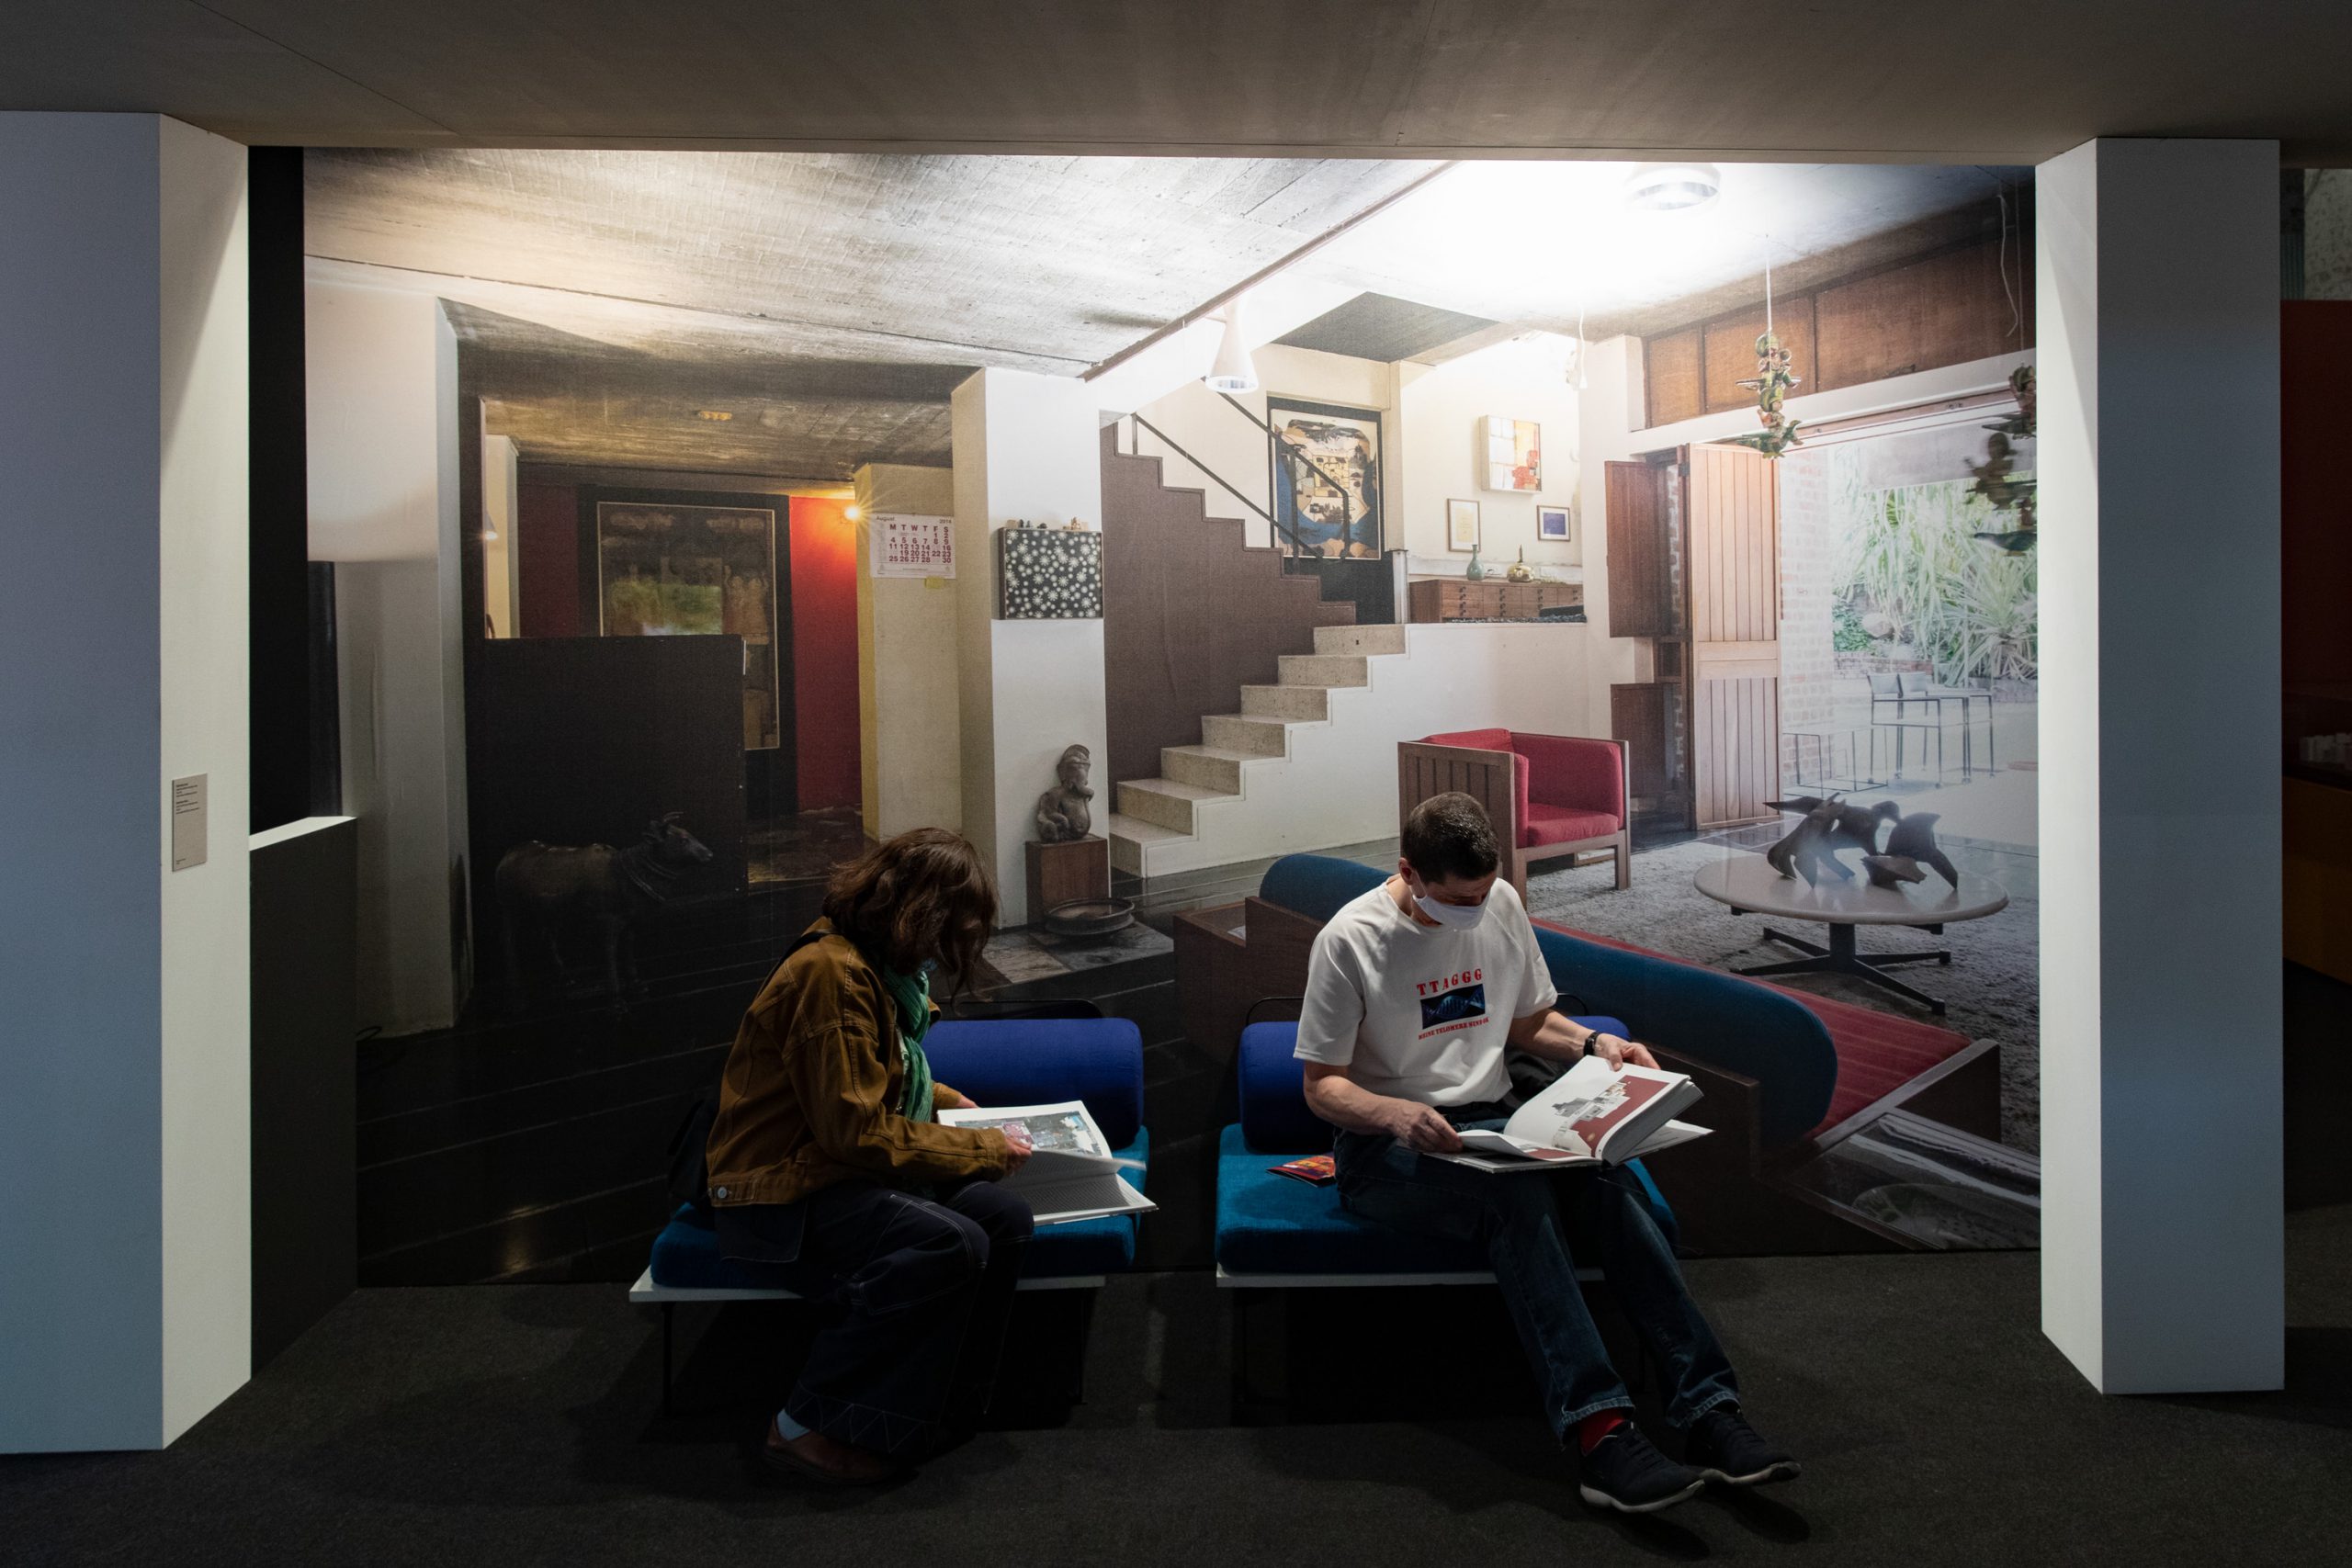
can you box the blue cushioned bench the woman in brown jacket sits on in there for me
[628,1018,1150,1408]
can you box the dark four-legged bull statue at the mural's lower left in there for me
[494,811,710,1004]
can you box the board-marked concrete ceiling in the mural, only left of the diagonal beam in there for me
[303,151,1425,479]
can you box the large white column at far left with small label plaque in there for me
[0,113,252,1453]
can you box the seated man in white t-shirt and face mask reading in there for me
[1298,795,1797,1514]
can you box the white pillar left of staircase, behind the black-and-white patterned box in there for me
[953,369,1113,926]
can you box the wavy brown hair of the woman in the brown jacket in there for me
[826,828,997,985]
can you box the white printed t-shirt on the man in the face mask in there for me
[1296,879,1559,1105]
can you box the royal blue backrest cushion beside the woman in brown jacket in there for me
[922,1018,1143,1147]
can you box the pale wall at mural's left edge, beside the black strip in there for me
[303,278,470,1034]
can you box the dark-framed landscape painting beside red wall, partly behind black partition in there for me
[595,501,783,750]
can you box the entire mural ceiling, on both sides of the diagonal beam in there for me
[303,148,2023,479]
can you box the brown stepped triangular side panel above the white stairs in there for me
[1095,430,1355,795]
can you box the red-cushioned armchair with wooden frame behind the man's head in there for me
[1397,728,1633,900]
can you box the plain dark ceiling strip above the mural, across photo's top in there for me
[14,0,2352,164]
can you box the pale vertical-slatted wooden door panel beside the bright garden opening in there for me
[1684,446,1781,828]
